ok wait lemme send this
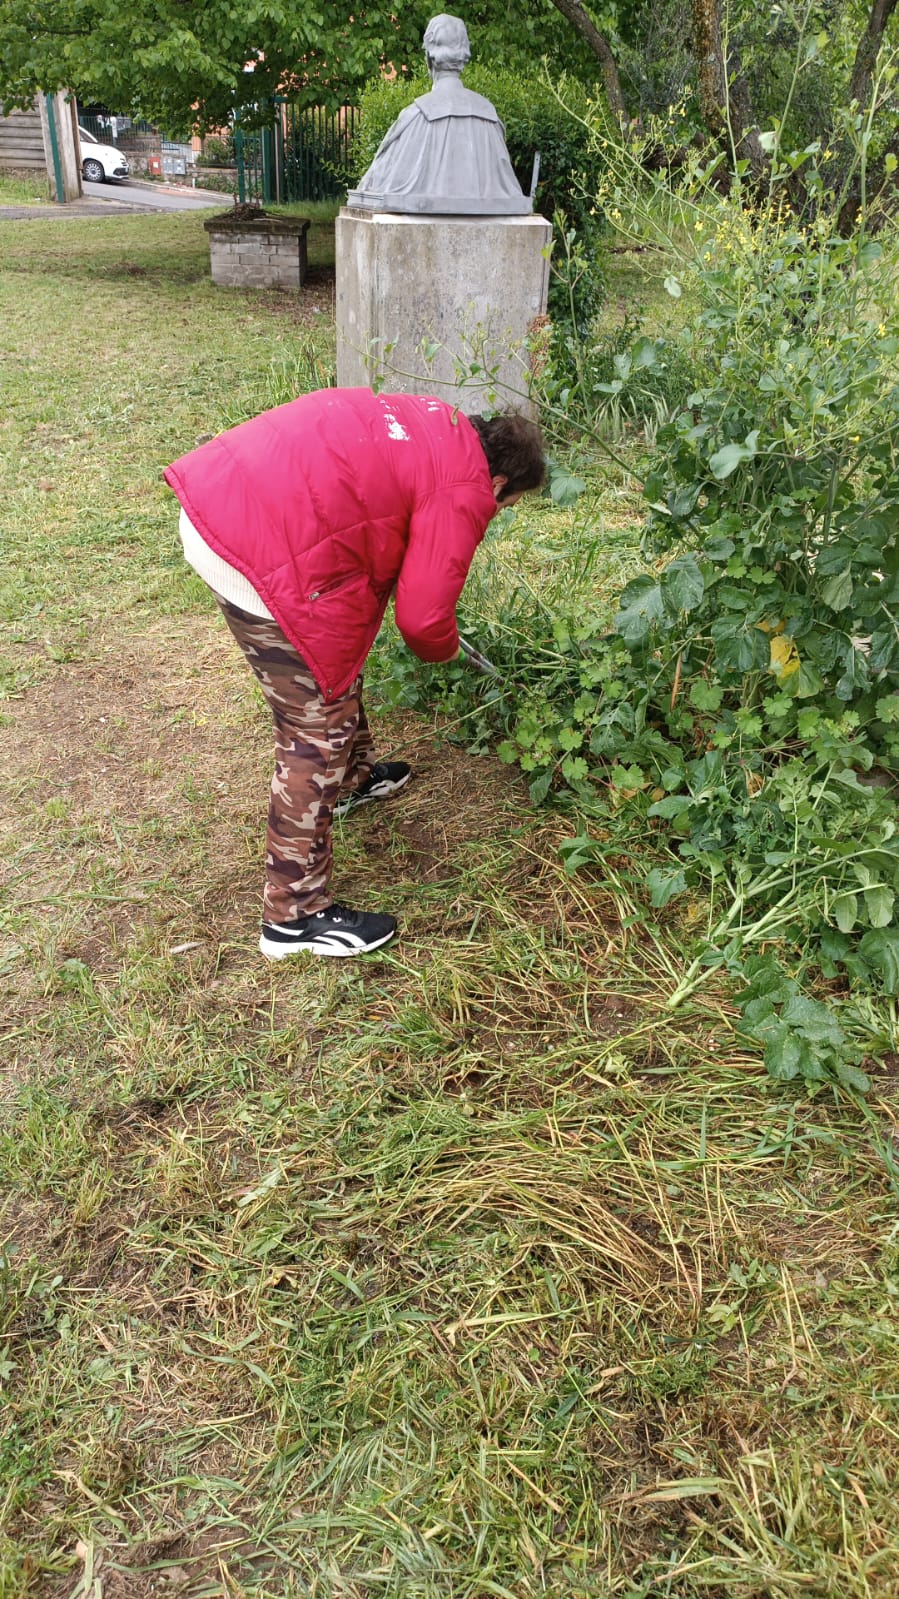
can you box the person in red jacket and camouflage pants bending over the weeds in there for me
[165,389,545,959]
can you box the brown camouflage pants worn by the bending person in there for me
[216,595,374,923]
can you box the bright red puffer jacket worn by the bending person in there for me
[165,389,496,699]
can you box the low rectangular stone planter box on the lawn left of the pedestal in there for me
[203,206,309,289]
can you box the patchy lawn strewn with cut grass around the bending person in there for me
[0,216,899,1599]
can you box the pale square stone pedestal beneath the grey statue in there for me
[338,206,552,411]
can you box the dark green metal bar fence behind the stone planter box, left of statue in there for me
[234,99,357,205]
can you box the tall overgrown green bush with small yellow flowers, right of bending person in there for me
[375,131,899,1068]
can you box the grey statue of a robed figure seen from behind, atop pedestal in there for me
[347,14,533,216]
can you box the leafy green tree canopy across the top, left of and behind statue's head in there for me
[0,0,590,133]
